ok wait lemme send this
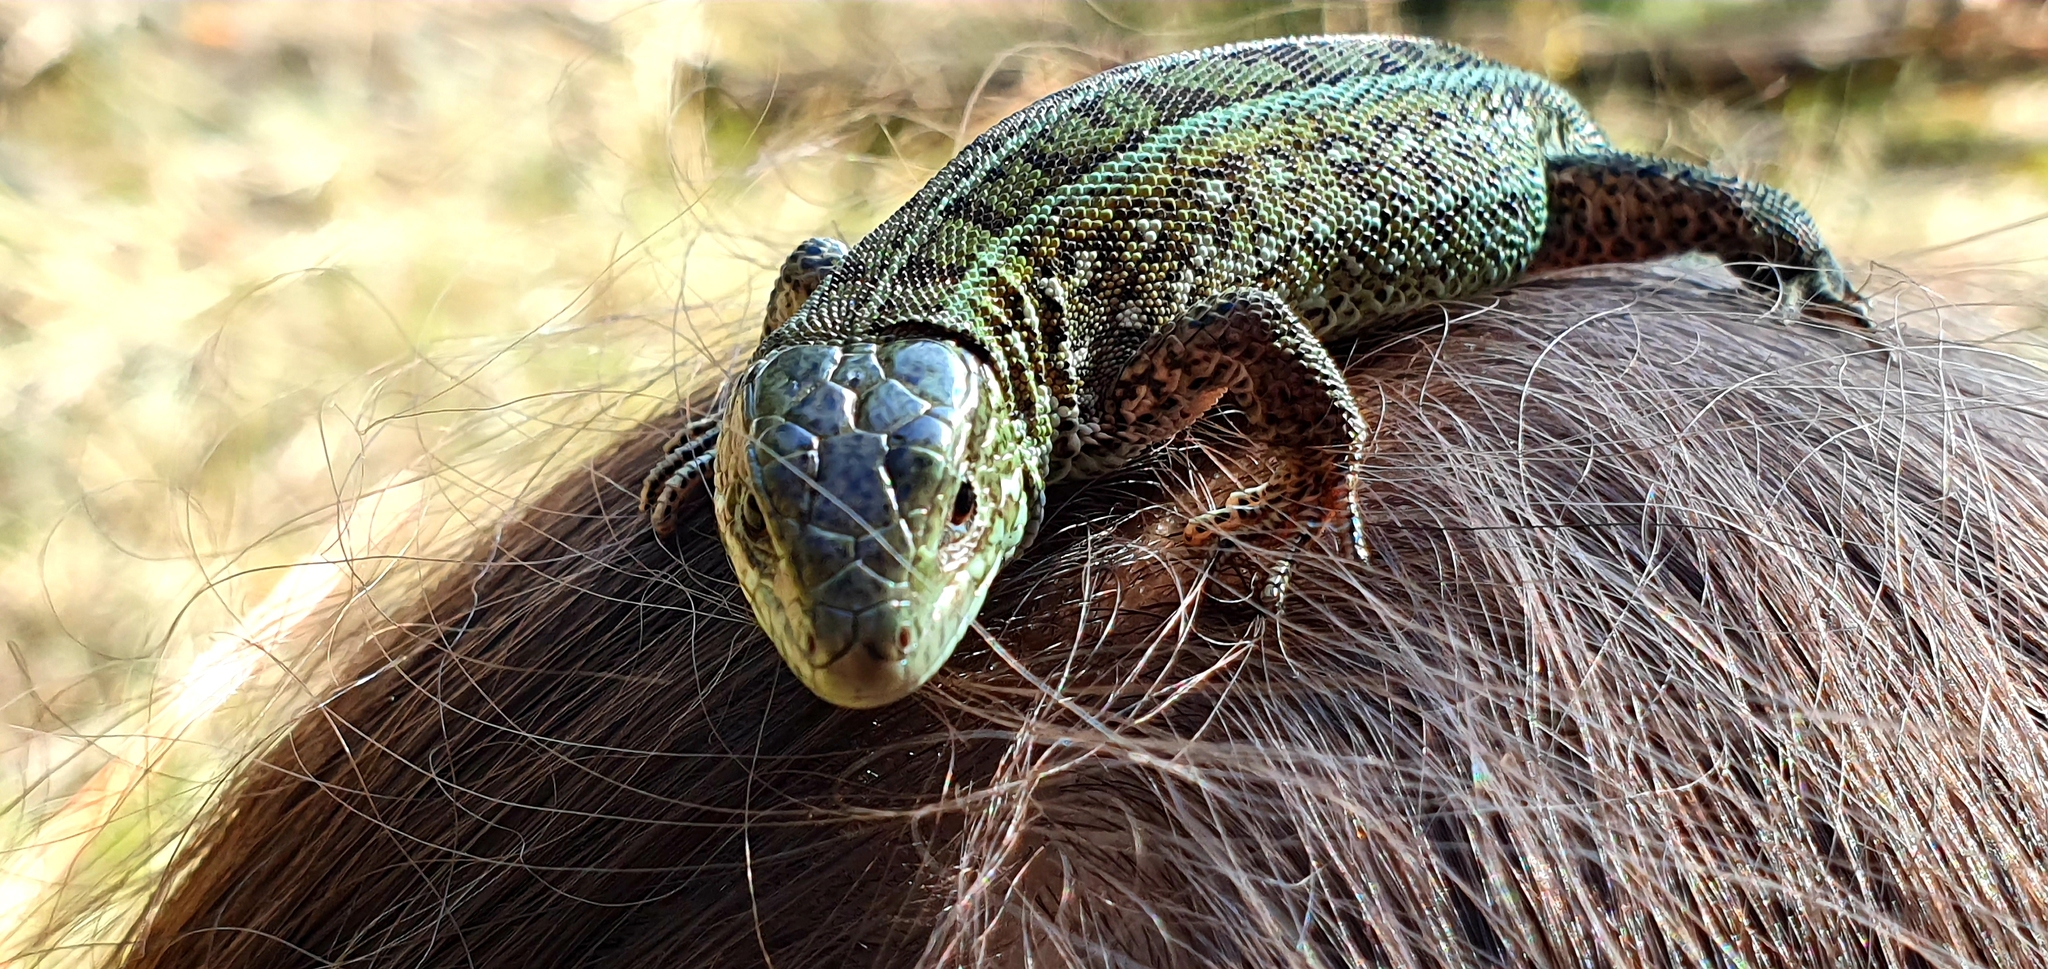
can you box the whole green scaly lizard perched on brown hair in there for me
[641,35,1868,709]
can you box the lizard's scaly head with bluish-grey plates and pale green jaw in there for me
[713,340,1032,709]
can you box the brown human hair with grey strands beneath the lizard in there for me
[119,272,2048,969]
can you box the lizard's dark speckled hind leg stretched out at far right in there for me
[1530,152,1870,328]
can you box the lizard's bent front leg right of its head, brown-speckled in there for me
[1096,291,1366,557]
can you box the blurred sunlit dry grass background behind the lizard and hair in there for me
[0,2,2048,955]
